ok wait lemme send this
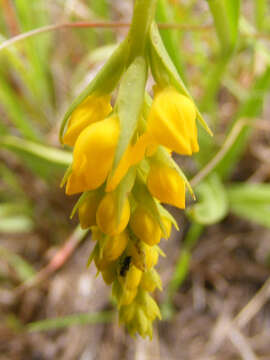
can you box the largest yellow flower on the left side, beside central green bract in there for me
[66,116,119,195]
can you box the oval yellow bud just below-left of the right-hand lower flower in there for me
[130,205,161,246]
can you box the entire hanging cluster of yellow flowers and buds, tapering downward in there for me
[63,86,199,338]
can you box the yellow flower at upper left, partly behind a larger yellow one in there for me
[63,94,112,146]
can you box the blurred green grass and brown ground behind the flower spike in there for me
[0,0,270,360]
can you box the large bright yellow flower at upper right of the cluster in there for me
[147,87,199,155]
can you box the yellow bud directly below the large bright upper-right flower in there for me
[147,163,185,209]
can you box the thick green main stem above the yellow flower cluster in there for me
[129,0,157,61]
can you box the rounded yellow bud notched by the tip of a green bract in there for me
[96,193,130,236]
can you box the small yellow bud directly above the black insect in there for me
[103,231,128,261]
